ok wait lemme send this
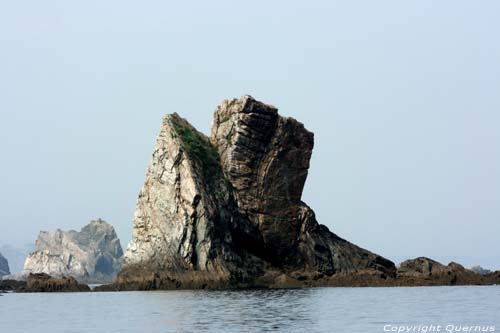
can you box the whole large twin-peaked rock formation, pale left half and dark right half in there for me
[113,96,396,289]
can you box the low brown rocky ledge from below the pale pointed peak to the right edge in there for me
[94,257,500,291]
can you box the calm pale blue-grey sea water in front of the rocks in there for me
[0,286,500,333]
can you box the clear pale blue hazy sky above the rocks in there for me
[0,0,500,269]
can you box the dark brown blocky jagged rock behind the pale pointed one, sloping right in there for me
[210,96,395,275]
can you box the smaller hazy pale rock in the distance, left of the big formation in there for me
[24,219,123,283]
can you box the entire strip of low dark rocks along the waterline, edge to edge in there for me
[0,257,500,293]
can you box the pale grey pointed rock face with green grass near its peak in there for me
[120,114,259,285]
